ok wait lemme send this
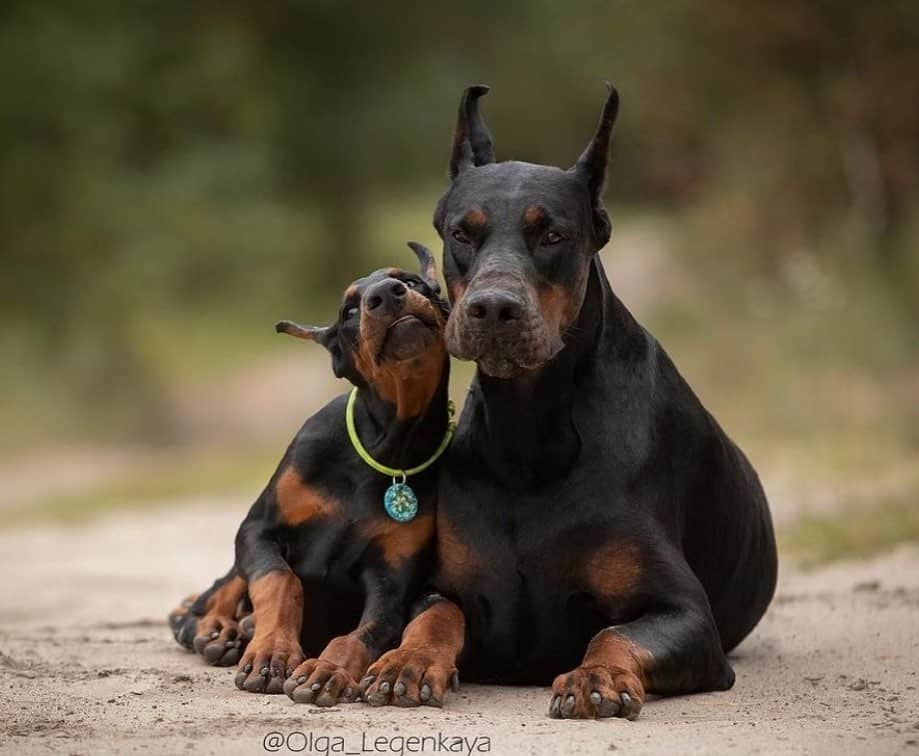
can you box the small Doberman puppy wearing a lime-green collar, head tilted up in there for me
[170,243,452,706]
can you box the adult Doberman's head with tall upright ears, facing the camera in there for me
[434,86,619,378]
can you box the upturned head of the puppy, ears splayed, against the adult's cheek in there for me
[276,242,449,417]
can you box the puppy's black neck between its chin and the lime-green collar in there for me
[354,355,450,469]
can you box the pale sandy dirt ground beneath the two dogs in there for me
[0,501,919,755]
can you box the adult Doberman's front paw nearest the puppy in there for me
[361,648,459,707]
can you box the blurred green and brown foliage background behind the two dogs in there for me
[0,0,919,548]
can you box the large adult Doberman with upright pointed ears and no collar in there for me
[363,87,776,718]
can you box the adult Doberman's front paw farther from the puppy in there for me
[549,664,645,719]
